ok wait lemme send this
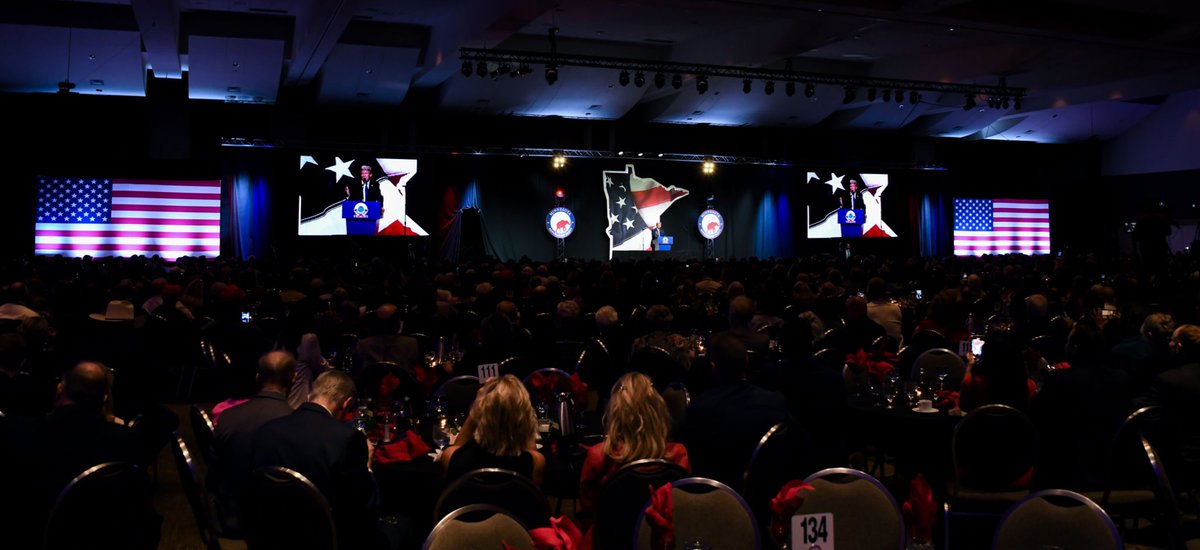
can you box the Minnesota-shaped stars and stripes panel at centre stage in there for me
[602,165,688,258]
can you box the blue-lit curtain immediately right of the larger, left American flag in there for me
[224,162,271,258]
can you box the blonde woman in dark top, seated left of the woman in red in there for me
[440,375,546,485]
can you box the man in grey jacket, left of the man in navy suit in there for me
[205,352,296,534]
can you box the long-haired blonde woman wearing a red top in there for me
[575,372,691,527]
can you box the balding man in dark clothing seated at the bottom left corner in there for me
[0,363,142,549]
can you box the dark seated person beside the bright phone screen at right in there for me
[959,330,1037,412]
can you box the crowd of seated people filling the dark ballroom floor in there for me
[0,248,1200,545]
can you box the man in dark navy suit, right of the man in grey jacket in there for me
[253,371,378,548]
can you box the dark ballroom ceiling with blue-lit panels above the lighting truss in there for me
[0,0,1200,143]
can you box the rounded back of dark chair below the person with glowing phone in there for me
[950,405,1038,491]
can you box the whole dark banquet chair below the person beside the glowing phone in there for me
[943,405,1039,548]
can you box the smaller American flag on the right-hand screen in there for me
[954,198,1050,256]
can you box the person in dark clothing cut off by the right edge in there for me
[1136,324,1200,490]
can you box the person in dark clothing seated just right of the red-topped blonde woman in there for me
[680,334,791,488]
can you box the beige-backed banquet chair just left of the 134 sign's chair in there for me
[634,478,753,550]
